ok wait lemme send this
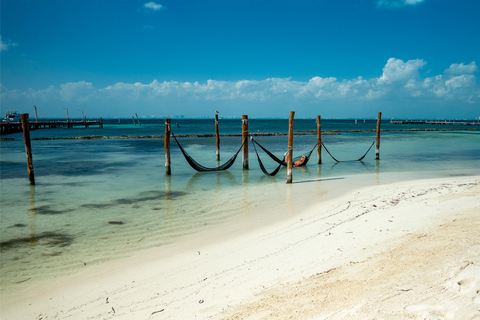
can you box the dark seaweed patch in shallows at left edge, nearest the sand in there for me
[0,232,73,252]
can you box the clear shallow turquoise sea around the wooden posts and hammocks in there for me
[0,119,480,292]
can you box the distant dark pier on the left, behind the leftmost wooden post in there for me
[0,118,103,135]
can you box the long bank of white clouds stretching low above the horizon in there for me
[1,58,480,116]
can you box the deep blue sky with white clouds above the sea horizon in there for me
[0,0,480,119]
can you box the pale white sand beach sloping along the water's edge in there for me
[0,176,480,319]
